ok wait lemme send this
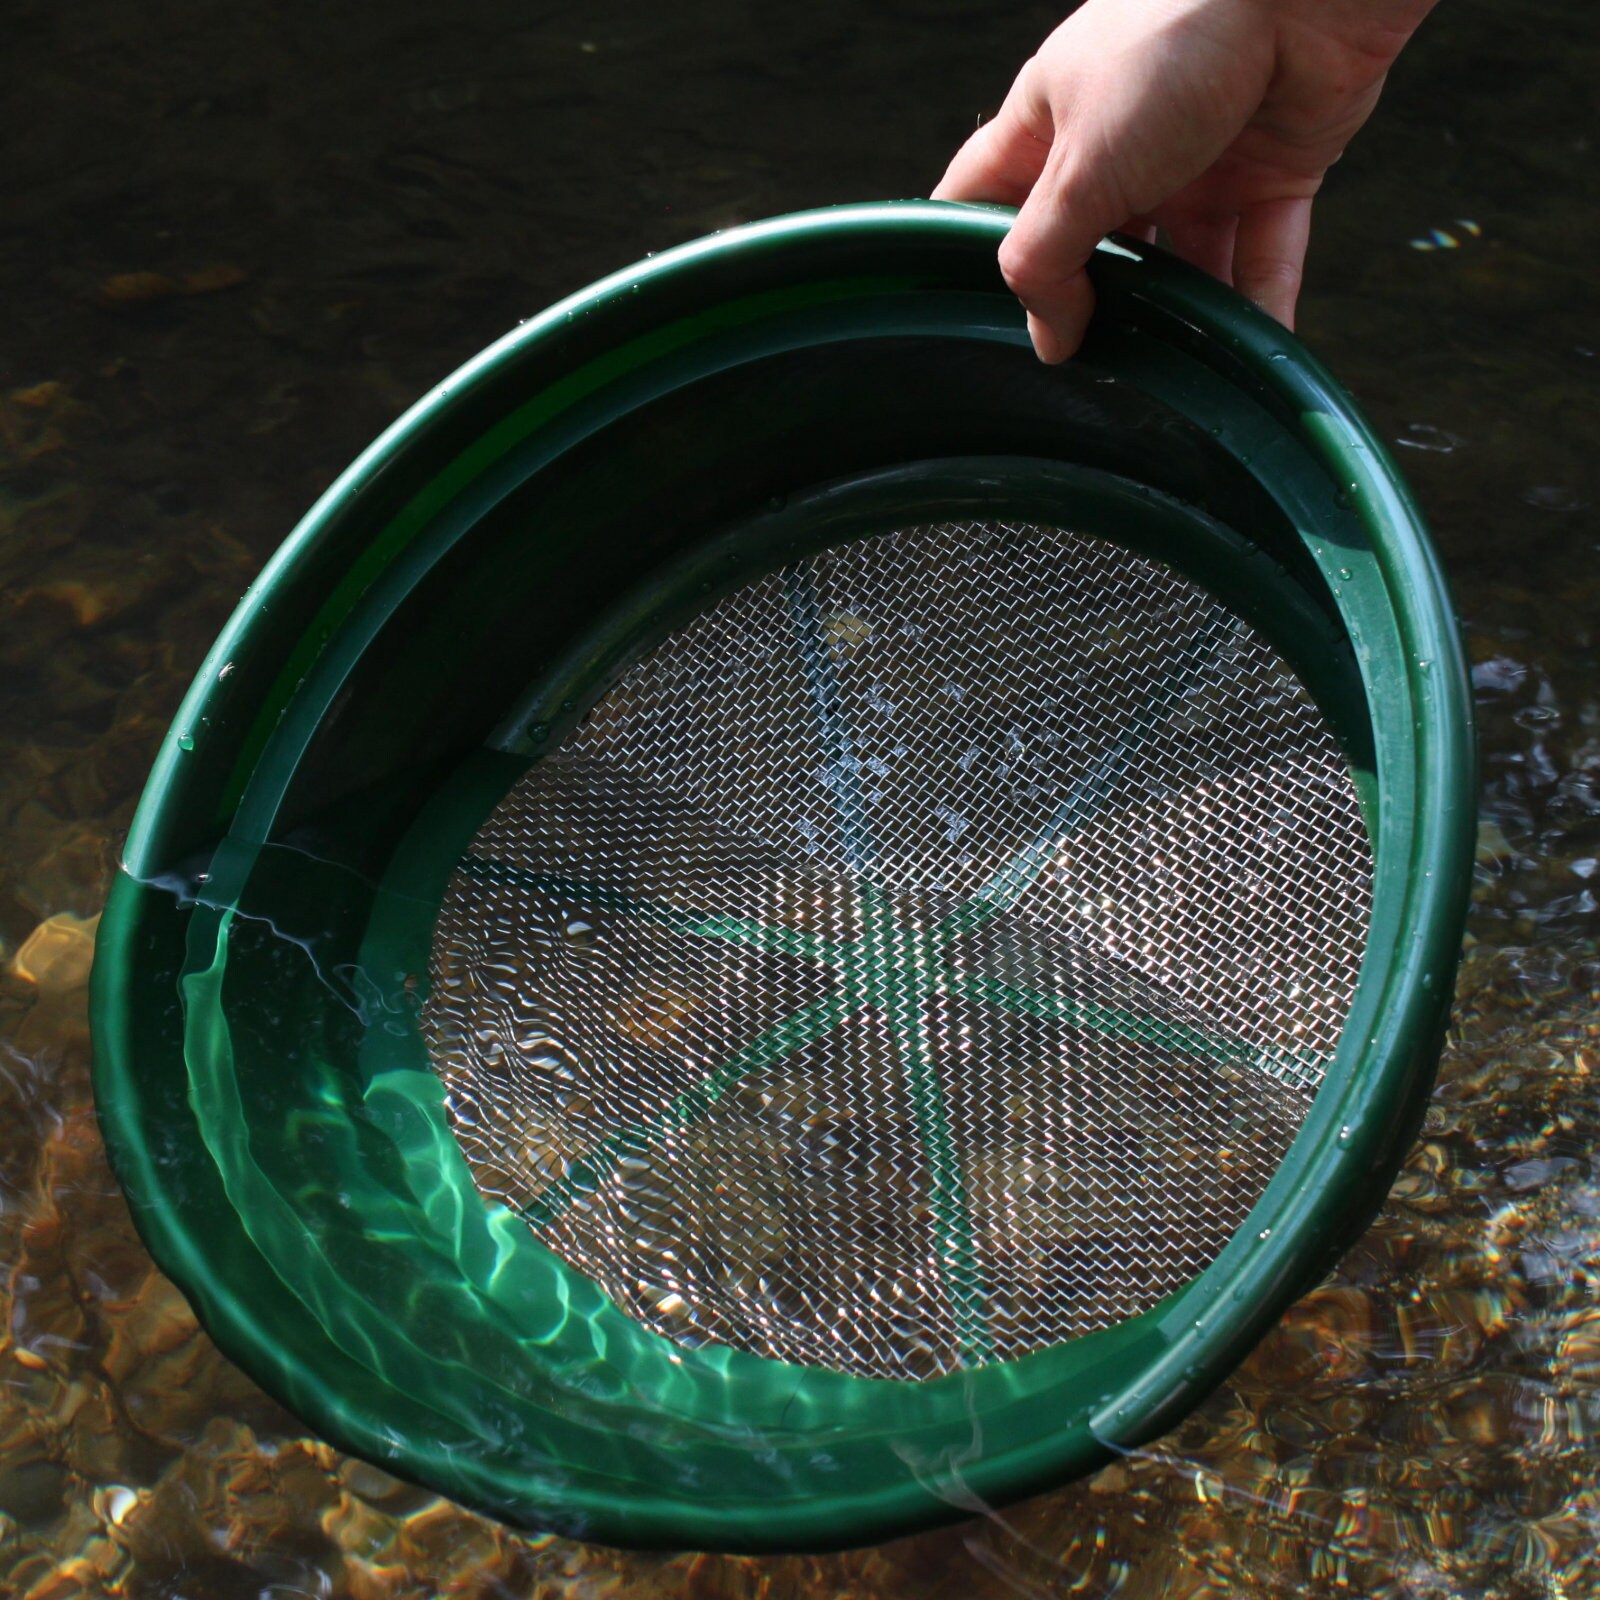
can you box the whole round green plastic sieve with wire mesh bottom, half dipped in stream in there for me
[93,202,1474,1550]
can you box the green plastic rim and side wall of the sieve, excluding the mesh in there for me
[91,202,1475,1550]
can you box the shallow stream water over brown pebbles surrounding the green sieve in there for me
[0,0,1600,1600]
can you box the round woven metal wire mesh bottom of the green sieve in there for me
[424,523,1371,1378]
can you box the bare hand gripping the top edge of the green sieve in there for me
[933,0,1434,362]
